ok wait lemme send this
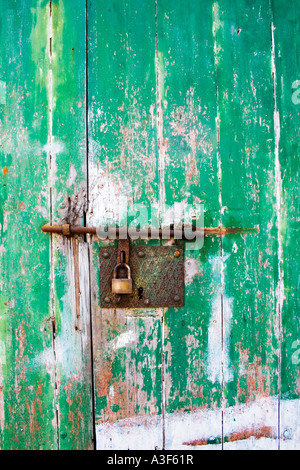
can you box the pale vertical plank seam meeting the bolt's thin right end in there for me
[213,2,225,450]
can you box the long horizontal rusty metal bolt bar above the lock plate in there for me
[42,224,259,240]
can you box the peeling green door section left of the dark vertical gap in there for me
[0,0,93,449]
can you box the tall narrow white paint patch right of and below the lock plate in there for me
[207,293,233,384]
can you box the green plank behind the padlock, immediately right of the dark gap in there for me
[88,0,163,449]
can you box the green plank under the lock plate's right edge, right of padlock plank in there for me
[157,0,222,449]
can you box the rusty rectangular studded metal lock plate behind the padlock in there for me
[100,245,184,308]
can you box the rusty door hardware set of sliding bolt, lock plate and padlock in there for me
[42,224,259,308]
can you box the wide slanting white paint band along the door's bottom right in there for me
[96,397,300,450]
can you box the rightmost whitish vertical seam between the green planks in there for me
[271,12,284,450]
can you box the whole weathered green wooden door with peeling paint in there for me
[0,0,300,450]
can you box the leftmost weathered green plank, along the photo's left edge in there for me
[0,0,57,449]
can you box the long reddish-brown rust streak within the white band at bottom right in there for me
[183,426,275,446]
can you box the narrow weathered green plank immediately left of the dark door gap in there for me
[47,0,94,450]
